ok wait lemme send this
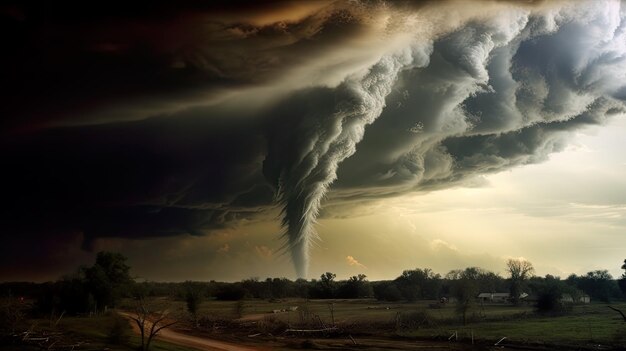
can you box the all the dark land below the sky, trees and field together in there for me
[0,252,626,351]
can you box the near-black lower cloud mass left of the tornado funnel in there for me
[1,108,272,260]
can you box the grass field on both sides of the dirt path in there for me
[8,298,626,351]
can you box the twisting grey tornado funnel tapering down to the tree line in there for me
[278,49,424,278]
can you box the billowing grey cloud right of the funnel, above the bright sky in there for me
[334,3,625,199]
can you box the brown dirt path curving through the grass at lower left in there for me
[119,312,260,351]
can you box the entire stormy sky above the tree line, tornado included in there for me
[0,0,626,281]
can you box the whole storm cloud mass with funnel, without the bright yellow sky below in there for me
[0,1,626,276]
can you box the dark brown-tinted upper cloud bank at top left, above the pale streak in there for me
[0,1,386,130]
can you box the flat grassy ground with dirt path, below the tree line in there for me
[0,297,626,351]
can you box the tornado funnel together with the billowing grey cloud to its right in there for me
[266,2,623,278]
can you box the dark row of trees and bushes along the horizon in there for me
[0,252,626,314]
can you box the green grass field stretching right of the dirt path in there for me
[140,299,626,347]
